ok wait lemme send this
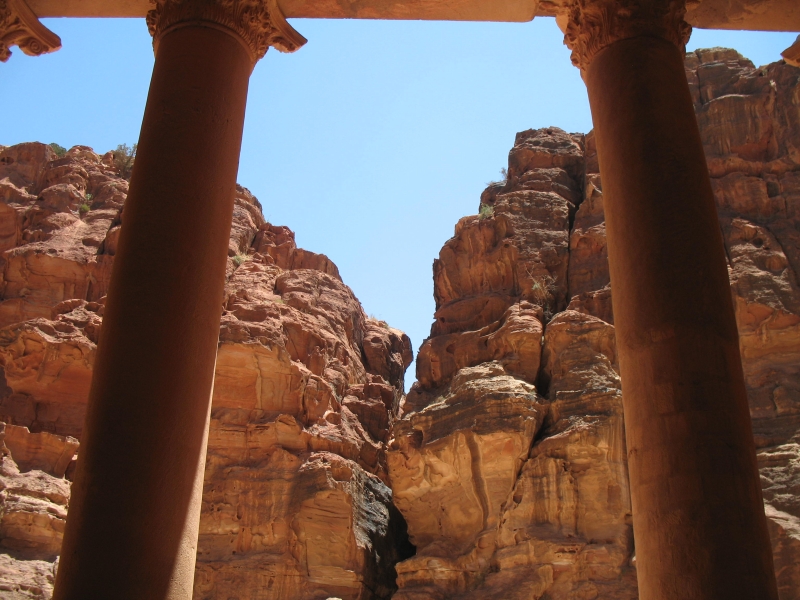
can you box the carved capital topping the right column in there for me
[558,0,692,72]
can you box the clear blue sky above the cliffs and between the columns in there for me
[0,19,796,390]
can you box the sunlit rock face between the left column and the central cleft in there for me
[195,229,413,600]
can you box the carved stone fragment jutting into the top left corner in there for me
[0,0,61,62]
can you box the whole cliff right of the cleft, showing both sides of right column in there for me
[388,49,800,600]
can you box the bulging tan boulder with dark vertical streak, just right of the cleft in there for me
[389,362,546,592]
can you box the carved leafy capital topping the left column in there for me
[145,0,306,64]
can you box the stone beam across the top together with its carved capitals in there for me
[0,0,800,63]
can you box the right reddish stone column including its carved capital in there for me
[561,0,778,600]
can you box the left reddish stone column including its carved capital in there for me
[55,0,305,600]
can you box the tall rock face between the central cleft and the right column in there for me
[389,128,636,600]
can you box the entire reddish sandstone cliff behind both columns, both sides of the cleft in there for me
[0,44,800,600]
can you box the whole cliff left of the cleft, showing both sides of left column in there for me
[0,143,413,600]
